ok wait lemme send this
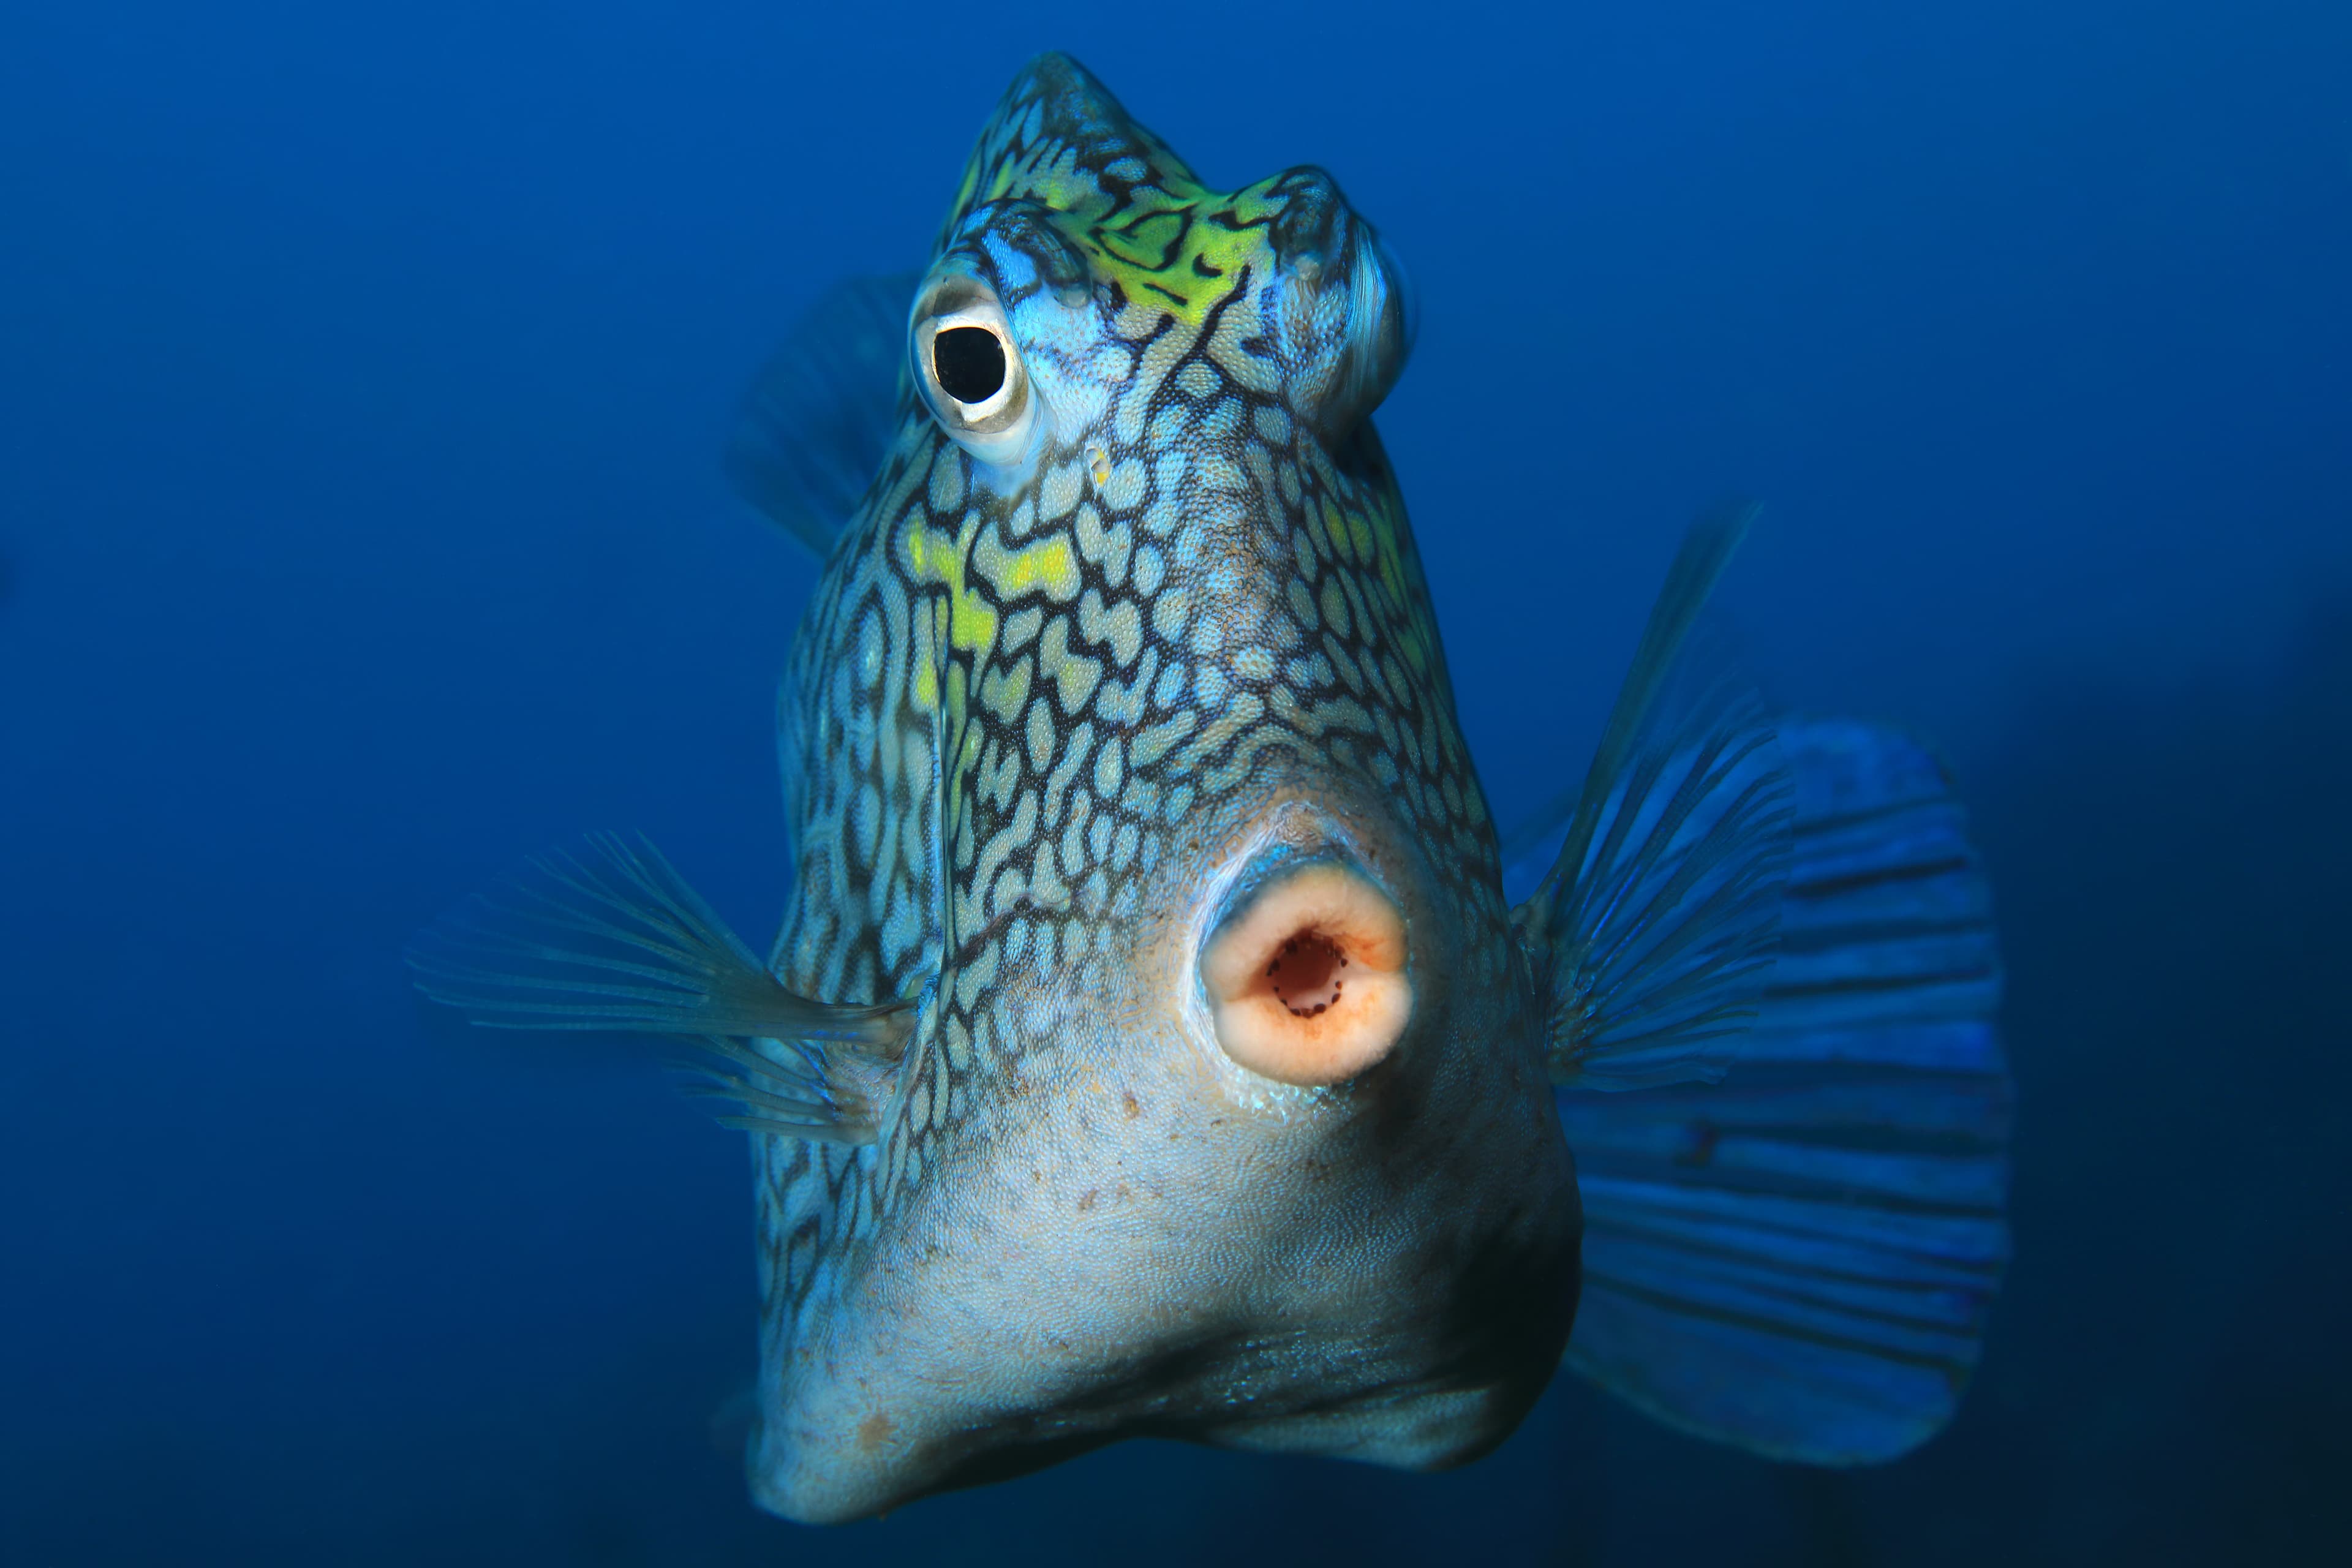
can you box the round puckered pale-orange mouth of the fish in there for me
[1199,861,1414,1084]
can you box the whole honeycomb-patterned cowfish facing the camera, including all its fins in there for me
[409,54,2008,1521]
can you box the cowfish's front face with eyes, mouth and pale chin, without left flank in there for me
[750,56,1580,1518]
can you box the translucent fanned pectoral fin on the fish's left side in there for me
[407,832,913,1142]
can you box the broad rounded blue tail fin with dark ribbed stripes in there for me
[1559,722,2011,1464]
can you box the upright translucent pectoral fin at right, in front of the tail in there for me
[1512,505,1790,1088]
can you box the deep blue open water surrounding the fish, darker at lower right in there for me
[0,0,2352,1568]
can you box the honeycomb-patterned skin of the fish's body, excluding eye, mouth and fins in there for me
[750,56,1576,1518]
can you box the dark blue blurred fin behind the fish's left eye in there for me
[725,273,918,559]
